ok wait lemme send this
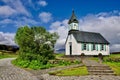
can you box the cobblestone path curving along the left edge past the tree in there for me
[0,58,38,80]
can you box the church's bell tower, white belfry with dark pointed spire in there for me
[68,10,79,31]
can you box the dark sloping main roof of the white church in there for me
[69,30,109,44]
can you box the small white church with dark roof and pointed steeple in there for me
[65,11,110,56]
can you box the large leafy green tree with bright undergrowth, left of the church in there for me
[13,26,58,69]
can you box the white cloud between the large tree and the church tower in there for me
[50,19,68,49]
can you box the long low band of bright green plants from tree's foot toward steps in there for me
[12,58,81,70]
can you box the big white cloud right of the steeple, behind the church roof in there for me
[80,13,120,51]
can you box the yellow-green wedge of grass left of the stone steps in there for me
[49,66,88,76]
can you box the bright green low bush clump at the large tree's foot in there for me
[12,54,51,70]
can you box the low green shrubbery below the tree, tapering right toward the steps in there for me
[12,53,81,70]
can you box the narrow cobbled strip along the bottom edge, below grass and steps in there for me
[42,74,120,80]
